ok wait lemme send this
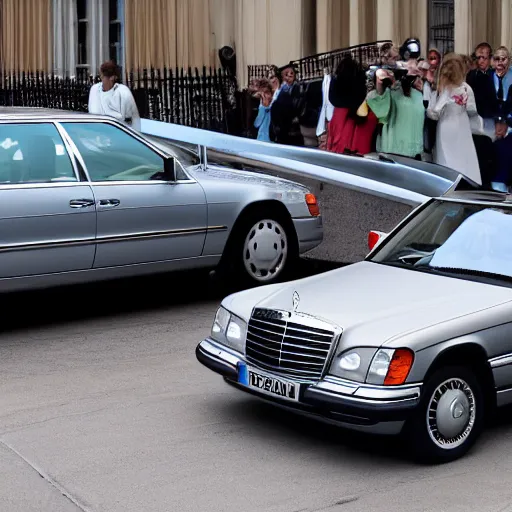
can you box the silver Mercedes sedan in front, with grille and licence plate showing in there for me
[196,190,512,462]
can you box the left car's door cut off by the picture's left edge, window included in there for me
[0,122,96,279]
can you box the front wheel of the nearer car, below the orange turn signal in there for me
[404,366,485,463]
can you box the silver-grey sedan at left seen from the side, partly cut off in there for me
[0,108,323,292]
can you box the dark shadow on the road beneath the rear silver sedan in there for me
[0,259,340,333]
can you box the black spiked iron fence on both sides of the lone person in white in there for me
[0,68,237,132]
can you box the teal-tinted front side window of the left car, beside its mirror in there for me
[62,123,164,181]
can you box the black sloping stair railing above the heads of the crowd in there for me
[248,40,391,83]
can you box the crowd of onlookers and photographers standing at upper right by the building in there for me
[250,38,512,192]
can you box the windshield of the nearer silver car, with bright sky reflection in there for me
[369,200,512,286]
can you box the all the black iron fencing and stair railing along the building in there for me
[0,41,387,136]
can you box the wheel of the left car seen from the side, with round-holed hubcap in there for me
[221,211,298,287]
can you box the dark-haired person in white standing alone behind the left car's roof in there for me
[89,61,140,131]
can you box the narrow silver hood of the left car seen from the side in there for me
[187,166,308,194]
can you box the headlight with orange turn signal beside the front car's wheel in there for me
[366,348,414,386]
